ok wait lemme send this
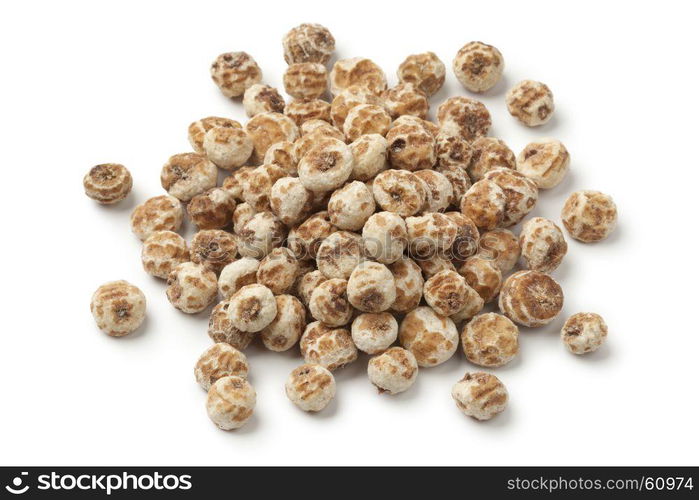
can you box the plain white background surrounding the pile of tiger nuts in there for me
[0,0,699,465]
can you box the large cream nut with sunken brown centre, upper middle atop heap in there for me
[298,138,354,191]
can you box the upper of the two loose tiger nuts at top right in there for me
[452,42,505,92]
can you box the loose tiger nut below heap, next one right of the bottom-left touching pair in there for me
[285,364,336,412]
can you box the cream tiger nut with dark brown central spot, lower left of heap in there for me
[228,284,277,332]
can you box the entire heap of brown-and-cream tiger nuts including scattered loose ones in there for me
[84,24,617,429]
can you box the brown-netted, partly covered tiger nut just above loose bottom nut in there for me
[299,321,357,371]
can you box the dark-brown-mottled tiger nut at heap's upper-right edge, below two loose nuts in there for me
[437,96,491,141]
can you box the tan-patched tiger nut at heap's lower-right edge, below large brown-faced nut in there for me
[461,313,519,368]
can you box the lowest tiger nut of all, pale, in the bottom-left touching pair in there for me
[206,377,257,431]
